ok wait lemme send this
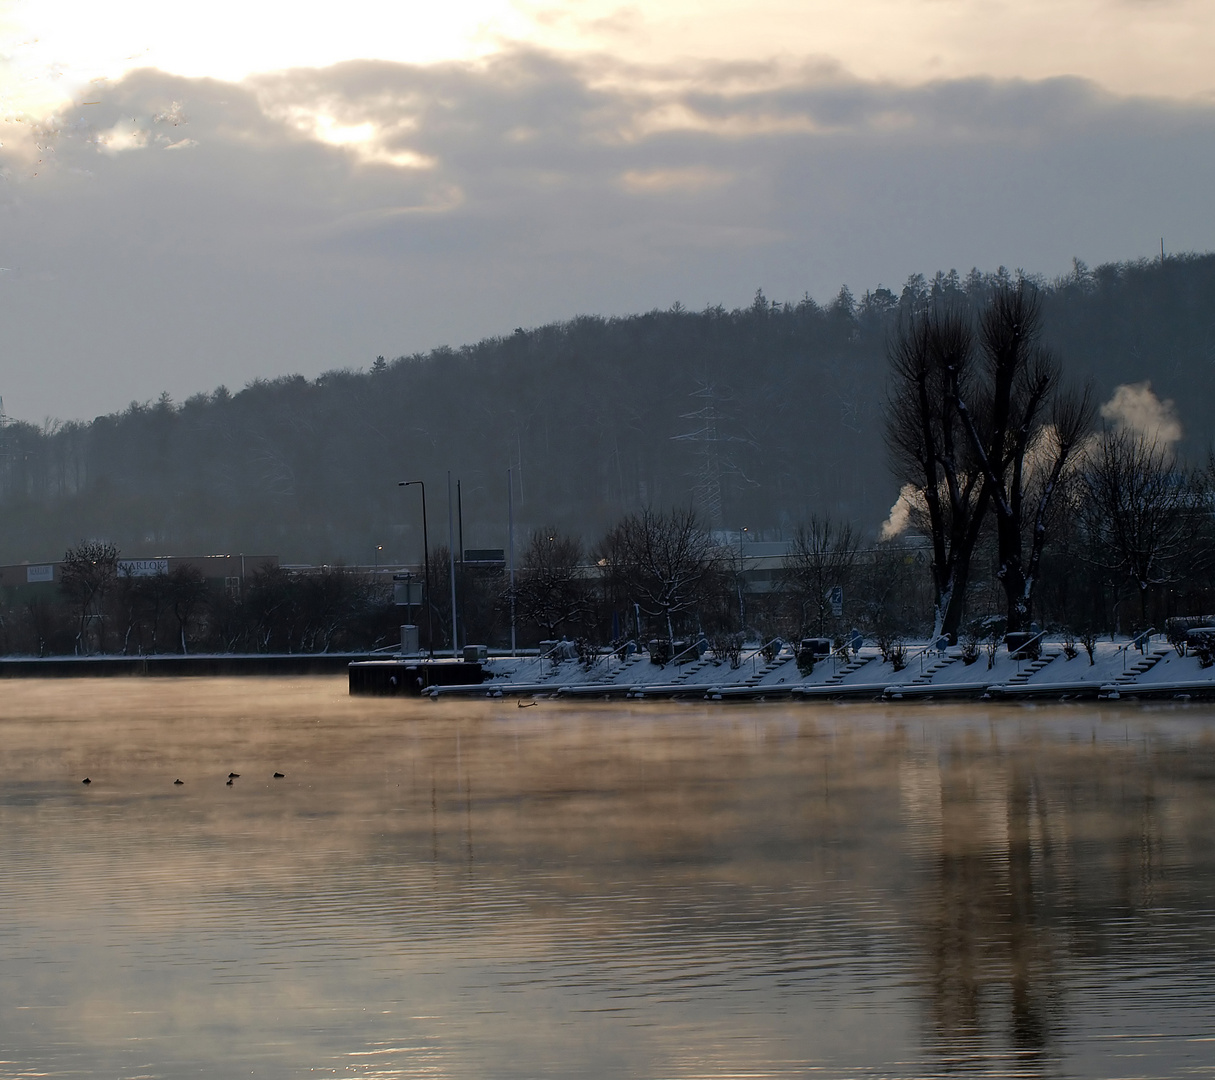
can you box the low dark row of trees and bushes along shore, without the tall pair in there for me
[0,464,1215,655]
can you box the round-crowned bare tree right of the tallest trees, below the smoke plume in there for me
[1081,431,1206,624]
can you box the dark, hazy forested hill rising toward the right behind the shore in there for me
[0,255,1215,564]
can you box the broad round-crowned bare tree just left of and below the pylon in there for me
[601,508,718,639]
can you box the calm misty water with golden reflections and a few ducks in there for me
[0,679,1215,1078]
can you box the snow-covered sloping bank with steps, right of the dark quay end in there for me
[430,639,1215,701]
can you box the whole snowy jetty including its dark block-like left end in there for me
[350,634,1215,702]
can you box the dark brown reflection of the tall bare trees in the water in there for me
[917,737,1185,1071]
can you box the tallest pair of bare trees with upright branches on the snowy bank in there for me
[887,281,1092,637]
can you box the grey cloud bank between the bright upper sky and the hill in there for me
[0,50,1215,417]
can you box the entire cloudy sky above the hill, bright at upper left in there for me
[0,0,1215,420]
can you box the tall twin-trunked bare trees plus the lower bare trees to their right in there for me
[886,281,1215,639]
